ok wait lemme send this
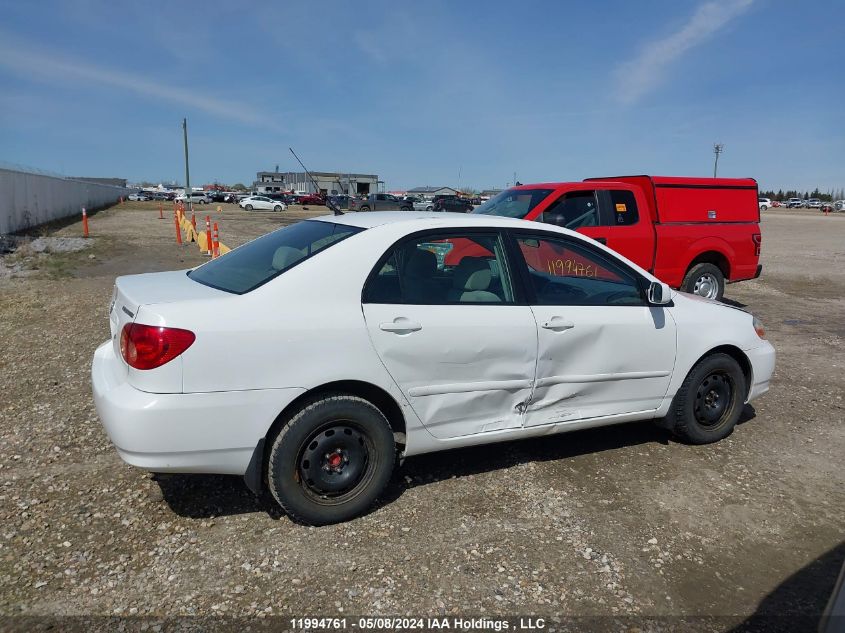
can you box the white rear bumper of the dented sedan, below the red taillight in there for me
[91,341,305,475]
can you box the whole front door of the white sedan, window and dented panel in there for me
[508,231,676,427]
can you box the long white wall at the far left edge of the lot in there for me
[0,168,130,234]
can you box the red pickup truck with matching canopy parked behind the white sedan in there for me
[473,176,762,300]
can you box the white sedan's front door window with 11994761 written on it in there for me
[517,236,645,306]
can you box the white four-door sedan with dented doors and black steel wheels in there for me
[92,212,775,524]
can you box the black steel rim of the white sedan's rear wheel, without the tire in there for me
[297,420,374,505]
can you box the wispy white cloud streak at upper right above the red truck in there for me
[616,0,754,104]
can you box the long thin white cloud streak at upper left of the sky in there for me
[0,38,282,131]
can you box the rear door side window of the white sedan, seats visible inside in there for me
[363,233,513,305]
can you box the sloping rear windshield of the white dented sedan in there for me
[188,220,363,294]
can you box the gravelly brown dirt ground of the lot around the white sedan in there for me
[0,203,845,631]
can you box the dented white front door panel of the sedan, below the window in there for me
[525,306,676,426]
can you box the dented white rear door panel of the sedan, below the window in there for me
[363,304,537,439]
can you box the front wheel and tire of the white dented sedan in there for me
[666,353,746,444]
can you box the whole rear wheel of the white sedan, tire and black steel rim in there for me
[267,394,396,525]
